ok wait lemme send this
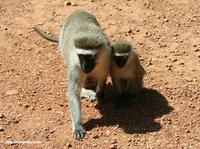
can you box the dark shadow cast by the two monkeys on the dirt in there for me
[84,88,173,134]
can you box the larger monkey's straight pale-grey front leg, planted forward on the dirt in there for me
[68,72,86,139]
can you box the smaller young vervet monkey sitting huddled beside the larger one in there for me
[110,40,145,107]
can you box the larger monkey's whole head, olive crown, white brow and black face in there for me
[74,37,103,73]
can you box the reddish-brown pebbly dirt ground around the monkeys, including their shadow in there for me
[0,0,200,149]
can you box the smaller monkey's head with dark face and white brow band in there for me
[111,40,132,68]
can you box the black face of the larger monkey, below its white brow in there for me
[78,54,96,73]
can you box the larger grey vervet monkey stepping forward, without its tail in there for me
[59,10,111,139]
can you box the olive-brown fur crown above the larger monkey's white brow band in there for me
[74,37,103,50]
